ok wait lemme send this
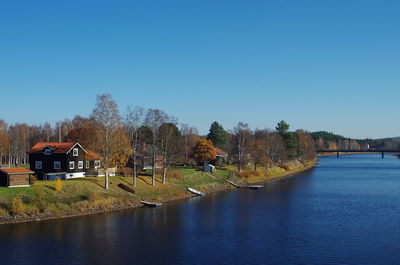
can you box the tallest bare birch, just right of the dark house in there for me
[92,94,120,189]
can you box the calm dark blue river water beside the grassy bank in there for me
[0,155,400,265]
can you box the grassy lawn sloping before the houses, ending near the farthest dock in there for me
[0,167,241,219]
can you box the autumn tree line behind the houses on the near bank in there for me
[0,94,315,185]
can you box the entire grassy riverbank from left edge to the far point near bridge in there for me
[0,160,316,224]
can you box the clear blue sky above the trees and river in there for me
[0,0,400,138]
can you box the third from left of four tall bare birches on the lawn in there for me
[145,109,168,186]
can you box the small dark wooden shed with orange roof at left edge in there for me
[0,168,34,187]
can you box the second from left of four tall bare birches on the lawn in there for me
[124,106,145,187]
